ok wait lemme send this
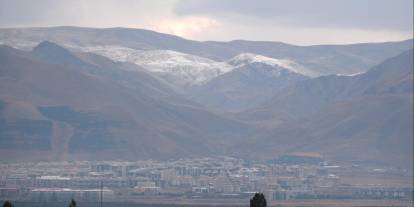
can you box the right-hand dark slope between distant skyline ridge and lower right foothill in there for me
[241,50,412,120]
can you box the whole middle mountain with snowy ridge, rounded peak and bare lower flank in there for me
[76,46,316,111]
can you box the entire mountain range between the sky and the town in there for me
[0,27,413,169]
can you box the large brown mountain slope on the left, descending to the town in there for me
[0,43,252,160]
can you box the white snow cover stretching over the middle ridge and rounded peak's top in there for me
[78,45,315,86]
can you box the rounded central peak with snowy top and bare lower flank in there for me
[190,56,309,112]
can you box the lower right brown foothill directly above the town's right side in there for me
[237,95,413,169]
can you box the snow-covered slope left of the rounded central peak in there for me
[80,46,233,85]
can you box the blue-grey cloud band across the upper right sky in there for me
[175,0,413,31]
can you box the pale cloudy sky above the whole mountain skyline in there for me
[0,0,413,45]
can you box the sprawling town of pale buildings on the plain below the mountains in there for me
[0,155,413,201]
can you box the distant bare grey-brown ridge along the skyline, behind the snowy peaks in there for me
[0,26,413,76]
